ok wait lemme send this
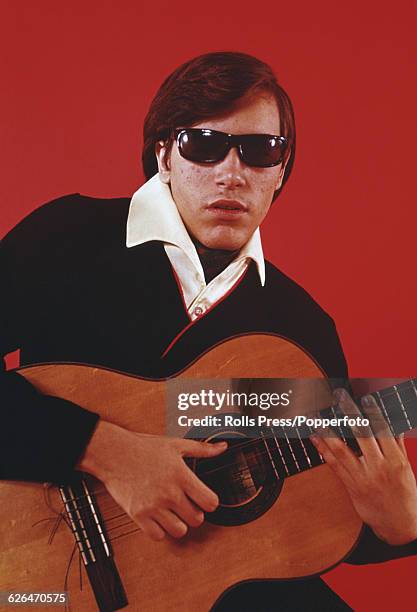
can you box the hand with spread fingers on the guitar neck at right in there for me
[311,389,417,545]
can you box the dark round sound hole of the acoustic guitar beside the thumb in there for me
[192,431,282,526]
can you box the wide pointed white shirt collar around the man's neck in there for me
[126,174,265,286]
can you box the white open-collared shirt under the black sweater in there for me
[126,174,265,320]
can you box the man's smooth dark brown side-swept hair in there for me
[142,51,295,199]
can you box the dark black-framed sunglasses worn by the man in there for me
[174,128,288,168]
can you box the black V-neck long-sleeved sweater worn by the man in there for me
[0,194,417,563]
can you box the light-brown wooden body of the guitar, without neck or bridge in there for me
[0,335,362,612]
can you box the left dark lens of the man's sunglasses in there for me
[178,130,228,163]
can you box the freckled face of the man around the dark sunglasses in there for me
[157,93,284,251]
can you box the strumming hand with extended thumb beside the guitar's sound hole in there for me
[77,421,227,540]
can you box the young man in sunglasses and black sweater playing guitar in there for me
[0,53,417,610]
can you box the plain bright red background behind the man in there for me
[0,0,417,611]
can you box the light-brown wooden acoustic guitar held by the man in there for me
[0,334,417,612]
